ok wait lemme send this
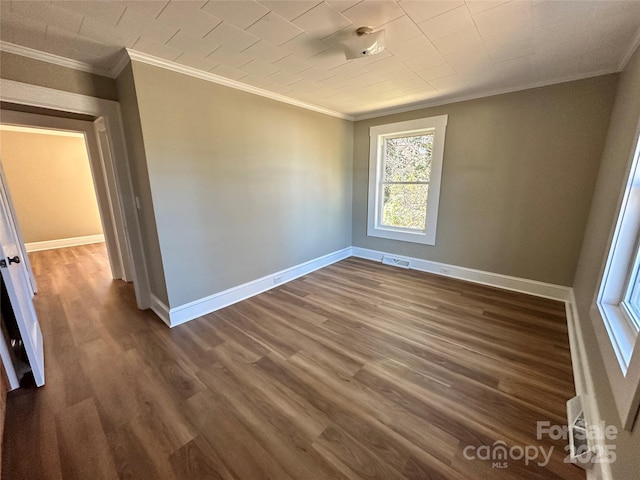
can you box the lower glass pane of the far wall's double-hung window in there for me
[382,184,429,230]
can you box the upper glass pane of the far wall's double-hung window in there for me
[383,133,433,182]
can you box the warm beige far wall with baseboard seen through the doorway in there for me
[0,124,104,258]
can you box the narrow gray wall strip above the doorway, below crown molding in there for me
[0,51,118,100]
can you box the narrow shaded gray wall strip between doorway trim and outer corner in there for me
[117,64,169,304]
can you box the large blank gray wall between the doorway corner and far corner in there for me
[127,62,353,307]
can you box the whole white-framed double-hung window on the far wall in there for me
[367,115,447,245]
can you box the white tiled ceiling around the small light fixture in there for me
[0,0,640,115]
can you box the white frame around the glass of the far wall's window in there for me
[367,115,448,245]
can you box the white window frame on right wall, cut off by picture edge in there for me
[591,126,640,430]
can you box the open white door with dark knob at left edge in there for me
[0,165,44,387]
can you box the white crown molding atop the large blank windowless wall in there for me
[127,49,353,121]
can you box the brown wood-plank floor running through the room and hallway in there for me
[2,244,584,480]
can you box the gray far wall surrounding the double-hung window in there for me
[353,75,617,285]
